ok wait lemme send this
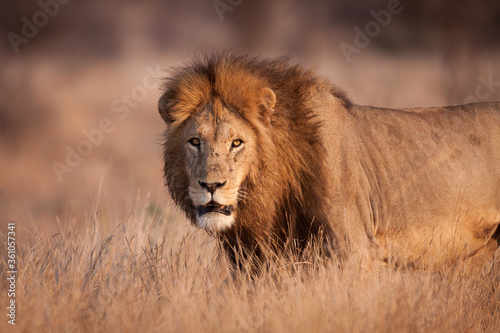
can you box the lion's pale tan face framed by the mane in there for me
[183,105,257,232]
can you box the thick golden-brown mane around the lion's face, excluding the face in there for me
[159,53,350,256]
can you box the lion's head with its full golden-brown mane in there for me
[158,54,342,249]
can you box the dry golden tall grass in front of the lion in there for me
[0,196,500,332]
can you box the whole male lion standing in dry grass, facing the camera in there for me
[158,53,500,268]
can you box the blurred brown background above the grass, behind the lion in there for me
[0,0,500,237]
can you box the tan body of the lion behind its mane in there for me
[313,92,500,267]
